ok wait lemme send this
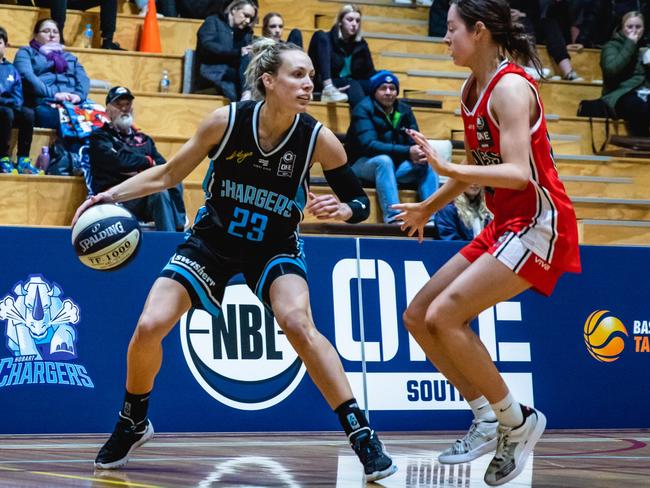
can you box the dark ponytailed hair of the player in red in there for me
[453,0,542,76]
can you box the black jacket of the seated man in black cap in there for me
[88,124,166,194]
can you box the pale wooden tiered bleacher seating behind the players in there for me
[0,0,650,244]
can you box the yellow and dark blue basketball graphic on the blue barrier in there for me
[585,310,629,363]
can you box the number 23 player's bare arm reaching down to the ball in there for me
[72,106,230,225]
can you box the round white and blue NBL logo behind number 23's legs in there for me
[180,284,306,410]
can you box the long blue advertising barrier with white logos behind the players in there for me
[0,227,650,434]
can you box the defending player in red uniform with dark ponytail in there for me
[395,0,580,485]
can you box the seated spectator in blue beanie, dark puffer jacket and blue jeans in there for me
[346,70,439,224]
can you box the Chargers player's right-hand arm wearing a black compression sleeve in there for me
[305,127,370,223]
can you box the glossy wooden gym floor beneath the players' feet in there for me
[0,430,650,488]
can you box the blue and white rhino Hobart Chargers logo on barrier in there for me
[0,275,94,388]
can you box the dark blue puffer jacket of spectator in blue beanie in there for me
[345,96,418,165]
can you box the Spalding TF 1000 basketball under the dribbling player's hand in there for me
[72,204,141,271]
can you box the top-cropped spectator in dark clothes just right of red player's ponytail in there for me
[539,0,583,81]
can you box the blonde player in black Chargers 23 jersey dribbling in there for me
[74,39,397,481]
